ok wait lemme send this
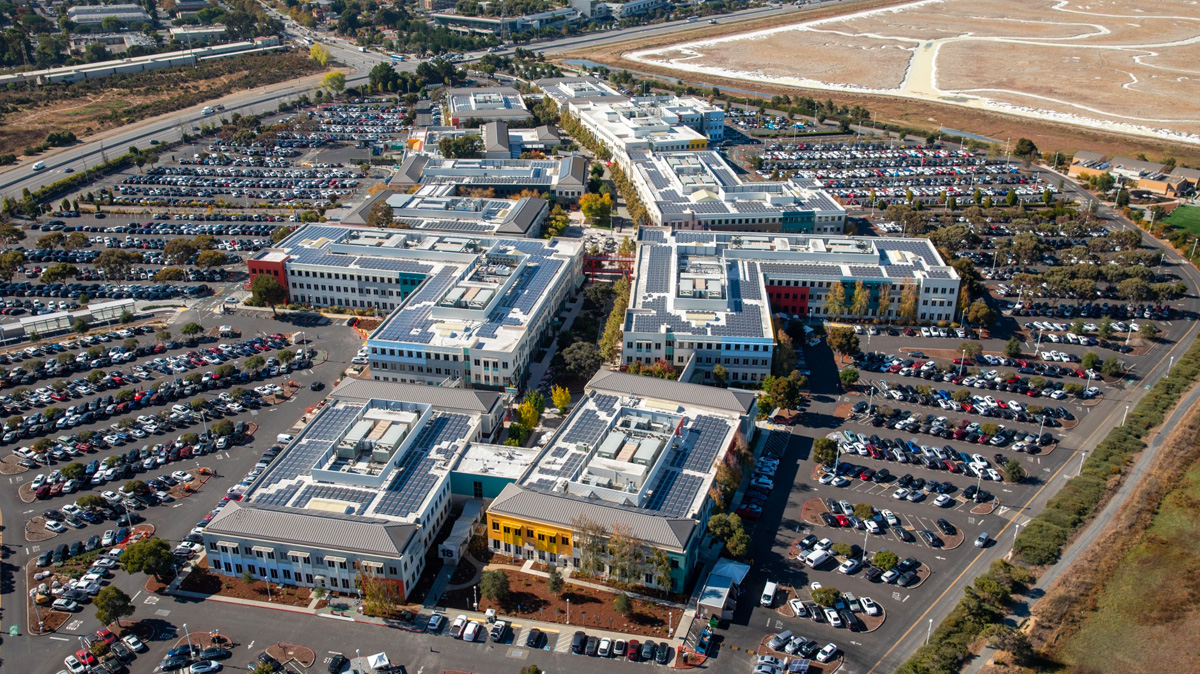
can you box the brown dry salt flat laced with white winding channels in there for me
[619,0,1200,145]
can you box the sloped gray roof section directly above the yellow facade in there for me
[487,485,697,550]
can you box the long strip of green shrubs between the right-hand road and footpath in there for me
[898,342,1200,674]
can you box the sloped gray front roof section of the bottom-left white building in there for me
[204,501,418,558]
